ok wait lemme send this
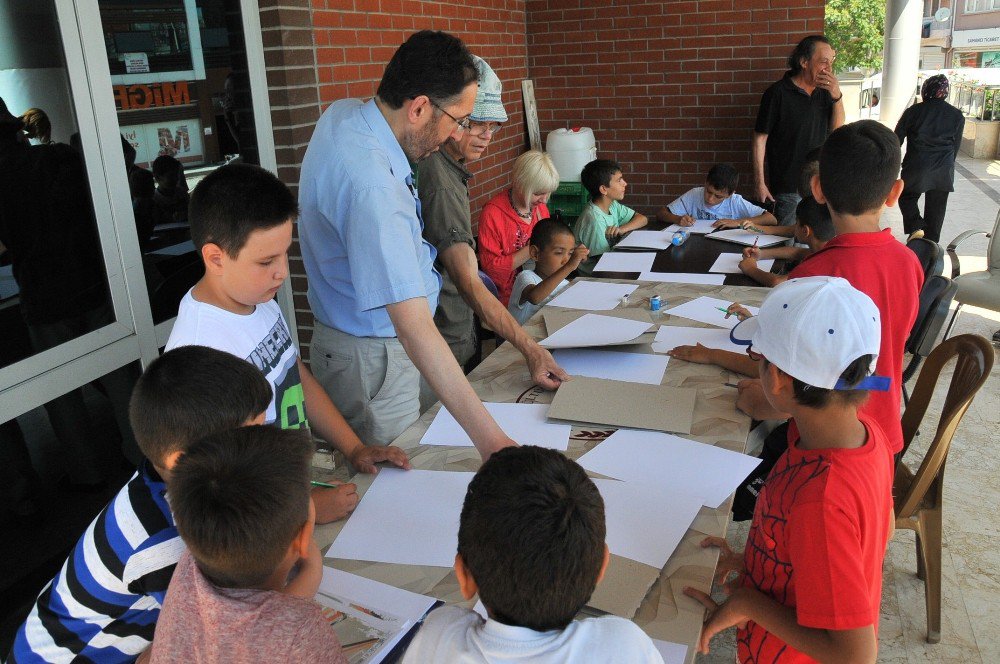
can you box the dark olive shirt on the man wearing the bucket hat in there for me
[417,148,476,364]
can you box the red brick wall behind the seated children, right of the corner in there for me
[526,0,824,214]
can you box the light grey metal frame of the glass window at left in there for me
[0,0,298,422]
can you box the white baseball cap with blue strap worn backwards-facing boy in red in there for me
[730,277,889,391]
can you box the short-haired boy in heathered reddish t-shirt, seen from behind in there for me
[140,426,347,664]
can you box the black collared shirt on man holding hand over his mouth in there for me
[754,71,834,194]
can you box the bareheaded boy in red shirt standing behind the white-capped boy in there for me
[736,120,924,454]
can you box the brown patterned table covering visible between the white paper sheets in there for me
[316,280,768,662]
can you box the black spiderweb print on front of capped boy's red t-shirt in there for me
[736,452,830,664]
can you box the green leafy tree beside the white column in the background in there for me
[825,0,885,74]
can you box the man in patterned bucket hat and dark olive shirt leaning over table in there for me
[417,56,566,410]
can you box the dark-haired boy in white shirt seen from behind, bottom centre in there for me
[403,446,663,664]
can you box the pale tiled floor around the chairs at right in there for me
[698,155,1000,664]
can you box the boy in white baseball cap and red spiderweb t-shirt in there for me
[685,277,893,664]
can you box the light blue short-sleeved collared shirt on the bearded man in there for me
[299,99,441,337]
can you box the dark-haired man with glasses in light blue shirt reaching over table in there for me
[299,30,513,459]
